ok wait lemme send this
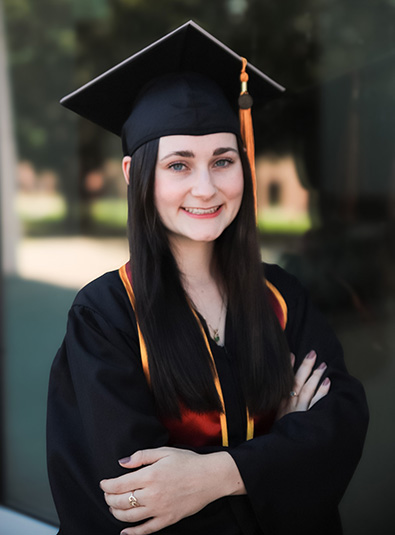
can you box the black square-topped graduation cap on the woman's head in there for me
[61,21,284,203]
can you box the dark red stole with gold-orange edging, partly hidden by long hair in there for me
[119,262,288,447]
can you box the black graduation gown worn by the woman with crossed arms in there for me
[47,265,368,535]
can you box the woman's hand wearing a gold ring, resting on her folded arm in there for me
[100,447,245,535]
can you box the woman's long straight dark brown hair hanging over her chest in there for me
[128,135,293,417]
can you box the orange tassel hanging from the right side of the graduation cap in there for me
[239,58,257,215]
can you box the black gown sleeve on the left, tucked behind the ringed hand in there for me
[47,278,168,535]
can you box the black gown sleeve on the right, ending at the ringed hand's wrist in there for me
[229,268,368,535]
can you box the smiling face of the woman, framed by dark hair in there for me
[154,133,244,246]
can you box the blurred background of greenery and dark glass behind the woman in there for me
[0,0,395,535]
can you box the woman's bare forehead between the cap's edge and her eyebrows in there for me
[158,132,237,157]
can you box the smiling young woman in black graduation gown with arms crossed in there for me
[48,22,367,535]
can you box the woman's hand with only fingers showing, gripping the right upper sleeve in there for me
[276,351,331,420]
